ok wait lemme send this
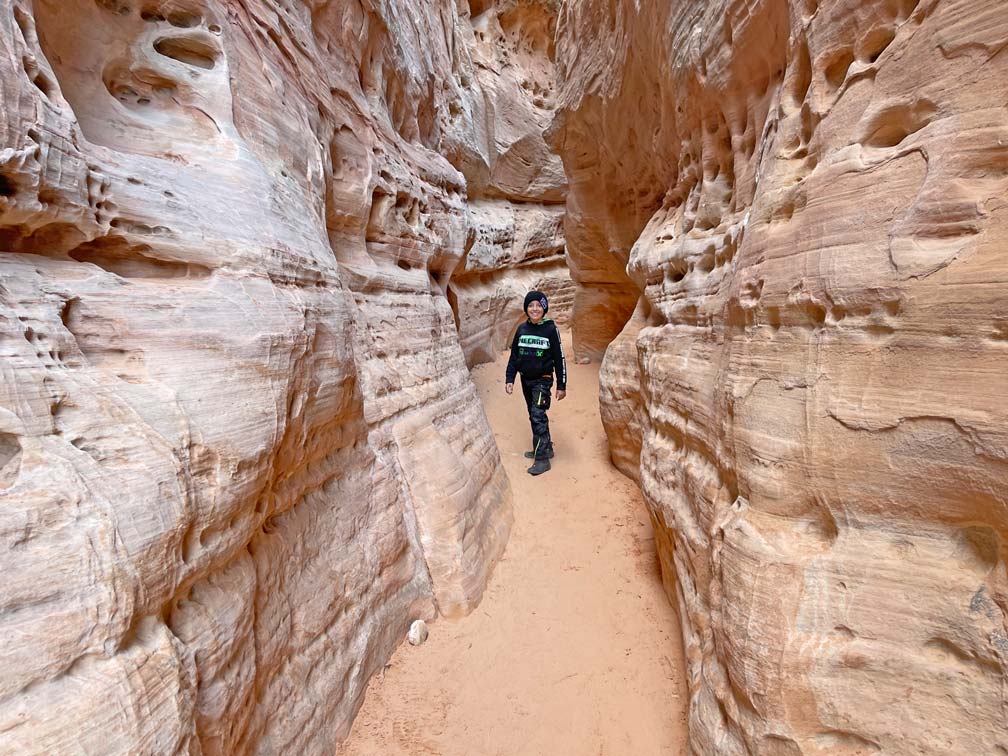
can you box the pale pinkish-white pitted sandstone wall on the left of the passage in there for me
[0,0,563,754]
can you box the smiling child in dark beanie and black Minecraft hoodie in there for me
[504,291,566,475]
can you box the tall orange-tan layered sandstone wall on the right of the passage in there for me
[553,0,1008,754]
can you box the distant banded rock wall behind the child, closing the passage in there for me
[449,0,574,366]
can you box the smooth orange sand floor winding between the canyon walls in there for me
[340,344,687,756]
